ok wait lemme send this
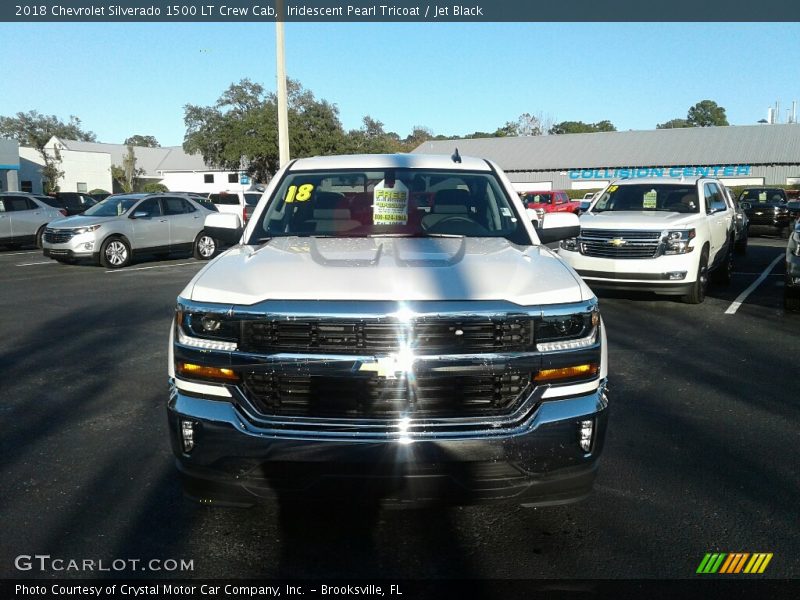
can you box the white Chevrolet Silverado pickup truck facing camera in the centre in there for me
[168,153,608,505]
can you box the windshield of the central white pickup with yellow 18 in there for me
[253,169,531,244]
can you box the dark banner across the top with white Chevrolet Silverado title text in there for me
[0,0,800,23]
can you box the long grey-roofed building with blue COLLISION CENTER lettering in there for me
[414,124,800,191]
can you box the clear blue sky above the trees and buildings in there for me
[0,23,800,145]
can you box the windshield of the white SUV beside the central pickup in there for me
[591,183,700,213]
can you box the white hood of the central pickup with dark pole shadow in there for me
[181,237,593,305]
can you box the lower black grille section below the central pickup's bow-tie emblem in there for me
[243,370,531,419]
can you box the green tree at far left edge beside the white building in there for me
[0,110,96,193]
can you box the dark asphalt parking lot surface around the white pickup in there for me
[0,238,800,579]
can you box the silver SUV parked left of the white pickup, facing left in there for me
[43,193,217,269]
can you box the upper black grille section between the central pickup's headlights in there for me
[241,317,533,354]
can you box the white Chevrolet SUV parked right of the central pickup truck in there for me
[560,178,735,304]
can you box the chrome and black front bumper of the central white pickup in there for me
[168,381,608,505]
